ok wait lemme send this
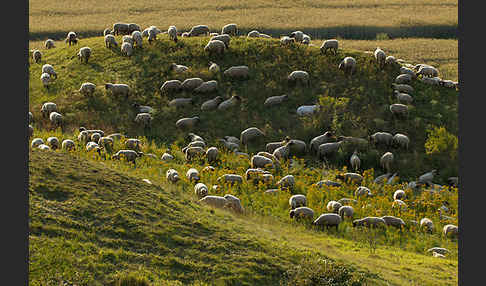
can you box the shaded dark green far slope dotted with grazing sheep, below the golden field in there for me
[29,36,458,183]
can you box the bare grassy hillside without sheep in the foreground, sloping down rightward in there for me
[29,149,457,285]
